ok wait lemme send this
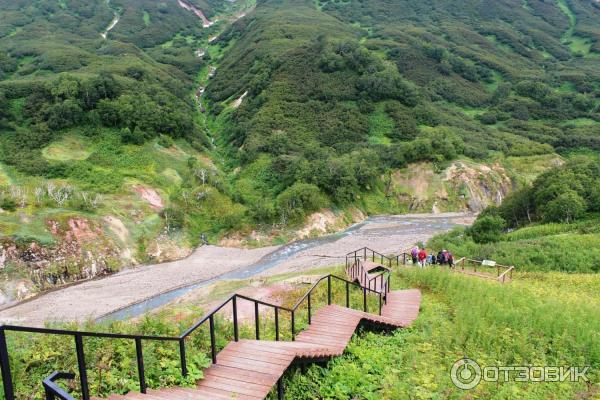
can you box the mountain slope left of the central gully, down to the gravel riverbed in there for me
[0,0,252,303]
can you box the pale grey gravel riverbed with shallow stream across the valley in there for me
[0,213,472,326]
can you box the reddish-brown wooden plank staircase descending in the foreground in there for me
[101,289,421,400]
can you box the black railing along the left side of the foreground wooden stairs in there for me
[0,274,390,400]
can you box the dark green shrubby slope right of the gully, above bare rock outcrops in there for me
[206,0,600,222]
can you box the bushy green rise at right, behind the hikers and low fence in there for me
[430,156,600,272]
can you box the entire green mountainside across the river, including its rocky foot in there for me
[0,0,600,304]
